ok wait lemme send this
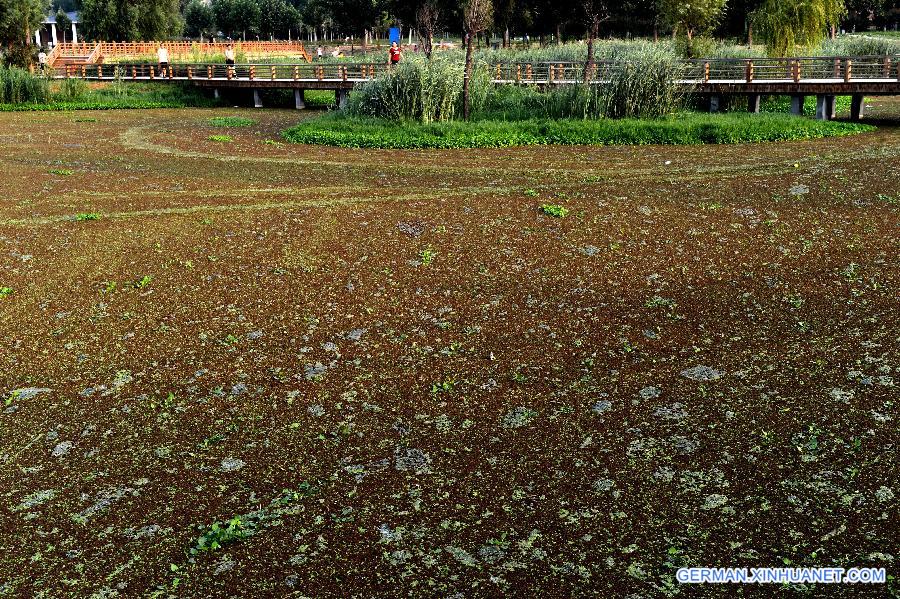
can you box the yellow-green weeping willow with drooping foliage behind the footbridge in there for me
[752,0,846,56]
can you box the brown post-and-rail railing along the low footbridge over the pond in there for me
[57,56,900,85]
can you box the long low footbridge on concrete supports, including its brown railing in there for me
[54,55,900,119]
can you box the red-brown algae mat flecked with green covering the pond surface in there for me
[0,100,900,598]
